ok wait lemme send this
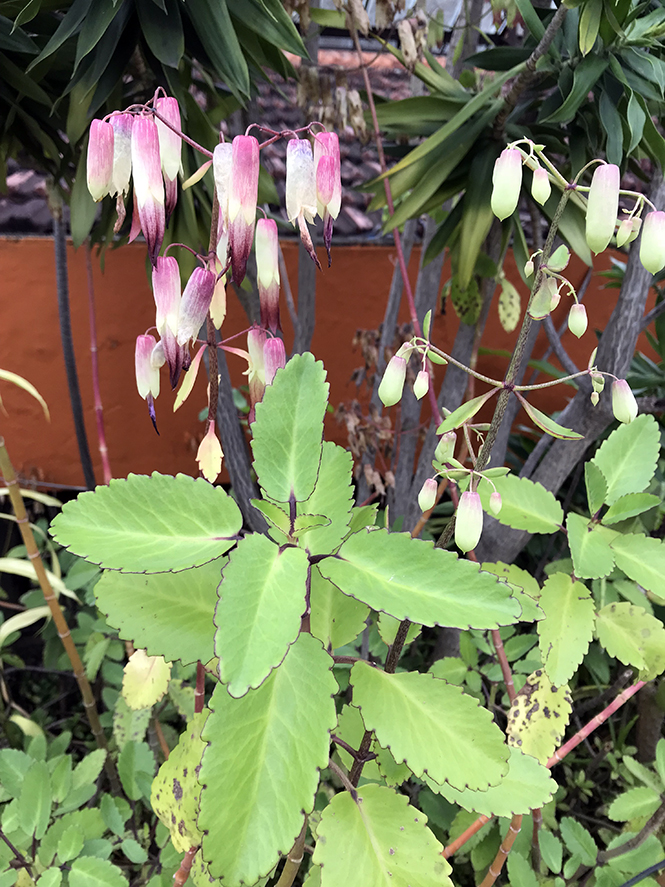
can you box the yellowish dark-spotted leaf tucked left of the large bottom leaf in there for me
[150,710,210,853]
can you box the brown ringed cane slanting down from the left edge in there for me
[0,437,120,794]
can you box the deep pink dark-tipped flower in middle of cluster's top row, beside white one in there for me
[228,136,260,286]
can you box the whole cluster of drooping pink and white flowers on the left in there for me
[87,90,342,482]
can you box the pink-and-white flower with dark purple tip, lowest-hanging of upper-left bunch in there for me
[132,117,166,265]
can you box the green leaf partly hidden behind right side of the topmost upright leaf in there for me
[297,441,353,554]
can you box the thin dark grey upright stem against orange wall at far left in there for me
[49,188,96,490]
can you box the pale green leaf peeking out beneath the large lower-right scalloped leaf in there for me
[427,748,557,816]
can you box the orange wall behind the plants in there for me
[0,238,653,485]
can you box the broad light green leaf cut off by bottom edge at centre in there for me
[312,785,452,887]
